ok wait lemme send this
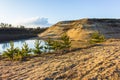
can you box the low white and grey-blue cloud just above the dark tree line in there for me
[14,17,51,27]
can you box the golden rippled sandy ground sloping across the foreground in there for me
[0,40,120,80]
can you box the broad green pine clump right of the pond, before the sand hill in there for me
[47,33,71,53]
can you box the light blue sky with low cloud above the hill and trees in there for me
[0,0,120,26]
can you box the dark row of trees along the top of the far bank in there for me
[0,23,47,34]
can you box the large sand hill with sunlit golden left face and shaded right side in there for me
[39,19,120,41]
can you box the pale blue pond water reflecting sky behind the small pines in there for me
[0,38,45,54]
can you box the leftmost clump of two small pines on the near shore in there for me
[2,42,31,61]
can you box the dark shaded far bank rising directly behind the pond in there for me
[0,24,47,42]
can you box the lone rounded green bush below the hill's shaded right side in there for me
[89,32,105,44]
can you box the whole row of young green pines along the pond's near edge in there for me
[2,34,71,61]
